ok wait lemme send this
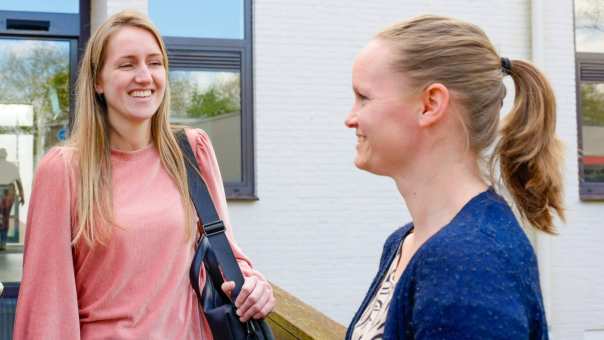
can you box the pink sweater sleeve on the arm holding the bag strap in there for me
[187,129,266,281]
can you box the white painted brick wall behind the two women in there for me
[92,0,604,340]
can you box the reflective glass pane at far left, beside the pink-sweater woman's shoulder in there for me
[0,39,70,248]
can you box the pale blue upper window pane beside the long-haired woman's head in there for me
[149,0,244,39]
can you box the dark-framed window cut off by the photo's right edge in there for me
[575,0,604,200]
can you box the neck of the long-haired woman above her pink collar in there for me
[109,115,151,151]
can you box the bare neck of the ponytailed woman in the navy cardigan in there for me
[393,157,487,242]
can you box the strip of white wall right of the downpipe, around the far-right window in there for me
[544,1,604,339]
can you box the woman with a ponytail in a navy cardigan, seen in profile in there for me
[346,16,563,340]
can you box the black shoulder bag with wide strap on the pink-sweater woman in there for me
[176,131,274,340]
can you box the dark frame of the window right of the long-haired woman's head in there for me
[158,0,258,200]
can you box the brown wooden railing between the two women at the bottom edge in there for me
[267,284,346,340]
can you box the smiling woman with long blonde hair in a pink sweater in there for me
[14,11,275,340]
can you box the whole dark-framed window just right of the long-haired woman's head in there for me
[149,0,256,199]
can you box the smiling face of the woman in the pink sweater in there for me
[95,26,166,127]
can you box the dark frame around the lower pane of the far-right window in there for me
[575,52,604,201]
